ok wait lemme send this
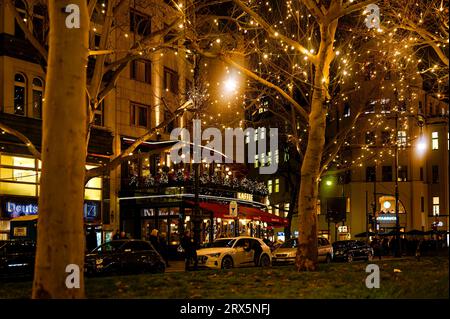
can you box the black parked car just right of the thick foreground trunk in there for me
[84,239,166,275]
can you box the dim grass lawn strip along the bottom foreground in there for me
[0,257,449,299]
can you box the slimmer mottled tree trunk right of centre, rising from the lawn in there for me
[296,19,338,271]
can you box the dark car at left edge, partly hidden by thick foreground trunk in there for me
[0,240,36,279]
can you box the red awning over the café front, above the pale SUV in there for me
[186,201,288,227]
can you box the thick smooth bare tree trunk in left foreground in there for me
[33,0,89,298]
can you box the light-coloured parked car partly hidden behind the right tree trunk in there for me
[272,237,333,265]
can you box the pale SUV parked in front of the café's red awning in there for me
[197,236,272,269]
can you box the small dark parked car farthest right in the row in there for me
[332,240,373,262]
